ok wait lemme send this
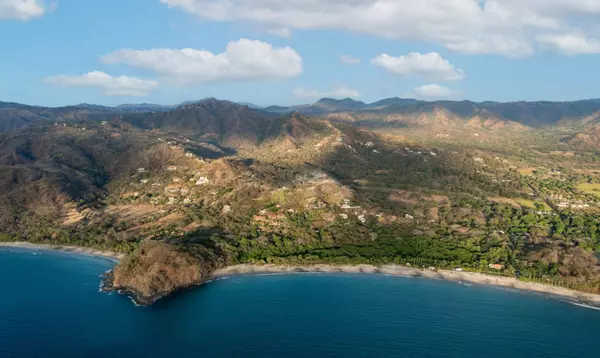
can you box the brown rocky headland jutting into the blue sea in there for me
[104,241,222,305]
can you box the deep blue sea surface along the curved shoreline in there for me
[0,248,600,358]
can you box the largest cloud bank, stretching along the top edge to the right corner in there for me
[161,0,600,57]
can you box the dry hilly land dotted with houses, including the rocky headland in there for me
[0,99,600,303]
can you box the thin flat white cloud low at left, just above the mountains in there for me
[44,71,158,97]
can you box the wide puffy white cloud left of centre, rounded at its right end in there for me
[102,39,303,83]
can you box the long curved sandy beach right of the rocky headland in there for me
[214,265,600,307]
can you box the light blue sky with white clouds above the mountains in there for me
[0,0,600,106]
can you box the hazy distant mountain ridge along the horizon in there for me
[0,97,600,132]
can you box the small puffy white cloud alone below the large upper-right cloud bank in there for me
[371,52,465,81]
